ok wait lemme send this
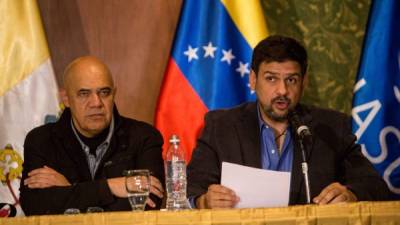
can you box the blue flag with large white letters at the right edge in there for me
[352,0,400,199]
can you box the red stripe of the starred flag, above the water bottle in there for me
[155,58,208,162]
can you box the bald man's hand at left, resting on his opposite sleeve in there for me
[24,166,71,188]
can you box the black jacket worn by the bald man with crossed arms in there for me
[20,107,164,215]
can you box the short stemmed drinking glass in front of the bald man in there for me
[125,170,150,211]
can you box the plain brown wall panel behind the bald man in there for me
[38,0,181,123]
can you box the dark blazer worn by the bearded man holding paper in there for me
[188,103,389,205]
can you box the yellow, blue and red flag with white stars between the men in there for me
[155,0,267,162]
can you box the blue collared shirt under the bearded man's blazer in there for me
[257,105,294,172]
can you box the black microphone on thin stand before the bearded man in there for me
[288,110,312,204]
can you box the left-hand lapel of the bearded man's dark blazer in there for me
[235,103,261,168]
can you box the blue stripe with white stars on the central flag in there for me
[172,0,255,110]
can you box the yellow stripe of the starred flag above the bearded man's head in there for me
[221,0,268,48]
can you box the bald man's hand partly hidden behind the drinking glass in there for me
[107,176,164,208]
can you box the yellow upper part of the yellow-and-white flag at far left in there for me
[0,0,49,96]
